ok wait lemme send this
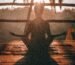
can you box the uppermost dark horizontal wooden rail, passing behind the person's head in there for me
[0,3,75,7]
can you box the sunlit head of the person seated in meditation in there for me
[34,3,44,18]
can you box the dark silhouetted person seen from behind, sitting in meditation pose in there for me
[10,4,62,65]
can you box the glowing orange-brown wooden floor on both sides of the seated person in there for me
[0,40,75,65]
